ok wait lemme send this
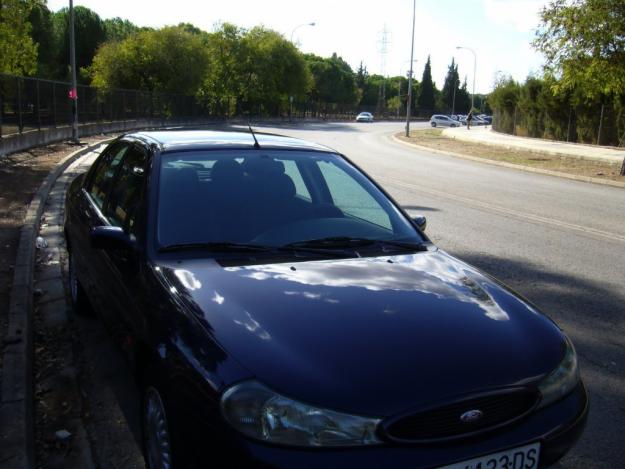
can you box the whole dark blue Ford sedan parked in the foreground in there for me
[65,131,588,469]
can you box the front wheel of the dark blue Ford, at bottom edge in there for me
[141,382,173,469]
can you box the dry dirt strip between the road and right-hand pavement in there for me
[397,129,625,182]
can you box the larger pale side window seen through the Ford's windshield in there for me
[317,161,392,230]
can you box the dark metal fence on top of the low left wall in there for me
[0,74,206,138]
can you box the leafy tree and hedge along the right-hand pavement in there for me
[489,0,625,146]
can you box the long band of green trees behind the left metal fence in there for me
[0,0,478,118]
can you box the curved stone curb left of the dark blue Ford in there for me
[0,137,115,469]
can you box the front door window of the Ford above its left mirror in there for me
[104,146,147,234]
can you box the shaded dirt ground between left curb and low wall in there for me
[0,136,109,388]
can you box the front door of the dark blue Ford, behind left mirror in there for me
[100,143,149,344]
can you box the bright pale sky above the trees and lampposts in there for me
[48,0,548,93]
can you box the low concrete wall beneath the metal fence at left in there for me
[0,119,223,157]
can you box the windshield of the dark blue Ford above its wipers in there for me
[157,150,423,250]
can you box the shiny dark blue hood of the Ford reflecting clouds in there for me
[159,251,563,416]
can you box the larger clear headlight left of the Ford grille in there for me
[221,381,380,446]
